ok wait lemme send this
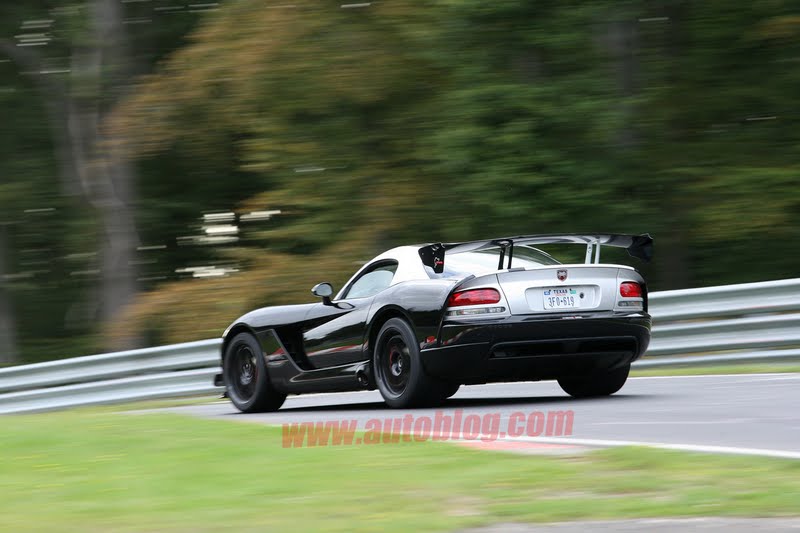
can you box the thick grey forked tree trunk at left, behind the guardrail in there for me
[0,0,139,349]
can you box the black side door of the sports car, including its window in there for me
[303,260,397,368]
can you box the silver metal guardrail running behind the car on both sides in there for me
[0,279,800,414]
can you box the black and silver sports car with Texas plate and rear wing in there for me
[215,234,653,412]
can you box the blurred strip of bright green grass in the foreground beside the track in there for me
[0,410,800,532]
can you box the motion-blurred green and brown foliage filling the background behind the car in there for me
[0,0,800,356]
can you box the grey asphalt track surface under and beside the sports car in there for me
[171,374,800,459]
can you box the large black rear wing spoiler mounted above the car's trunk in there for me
[419,233,653,274]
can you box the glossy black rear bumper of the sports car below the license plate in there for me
[420,312,652,383]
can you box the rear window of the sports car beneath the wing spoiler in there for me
[425,246,561,278]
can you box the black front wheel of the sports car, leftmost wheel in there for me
[222,333,286,413]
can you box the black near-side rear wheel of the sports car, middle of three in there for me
[373,318,444,408]
